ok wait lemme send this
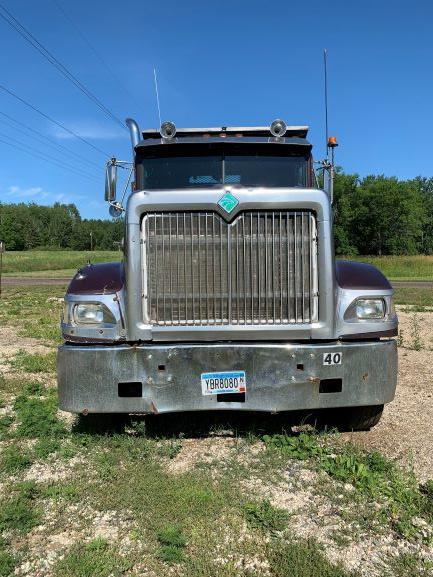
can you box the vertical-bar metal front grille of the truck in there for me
[143,211,318,326]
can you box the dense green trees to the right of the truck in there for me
[334,171,433,255]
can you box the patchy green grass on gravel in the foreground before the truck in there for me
[0,287,433,577]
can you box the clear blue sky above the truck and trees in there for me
[0,0,433,218]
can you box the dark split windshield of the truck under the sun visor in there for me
[137,154,307,189]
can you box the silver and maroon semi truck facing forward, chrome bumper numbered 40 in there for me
[58,119,398,430]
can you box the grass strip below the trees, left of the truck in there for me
[3,250,122,276]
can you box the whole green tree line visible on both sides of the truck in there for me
[0,170,433,255]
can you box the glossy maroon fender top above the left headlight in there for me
[66,262,125,295]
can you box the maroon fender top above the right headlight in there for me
[335,260,392,291]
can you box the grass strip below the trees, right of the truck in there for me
[339,255,433,281]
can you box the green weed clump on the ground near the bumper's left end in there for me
[14,394,65,438]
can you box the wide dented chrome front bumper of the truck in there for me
[58,340,397,413]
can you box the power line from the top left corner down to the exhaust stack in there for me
[0,4,127,130]
